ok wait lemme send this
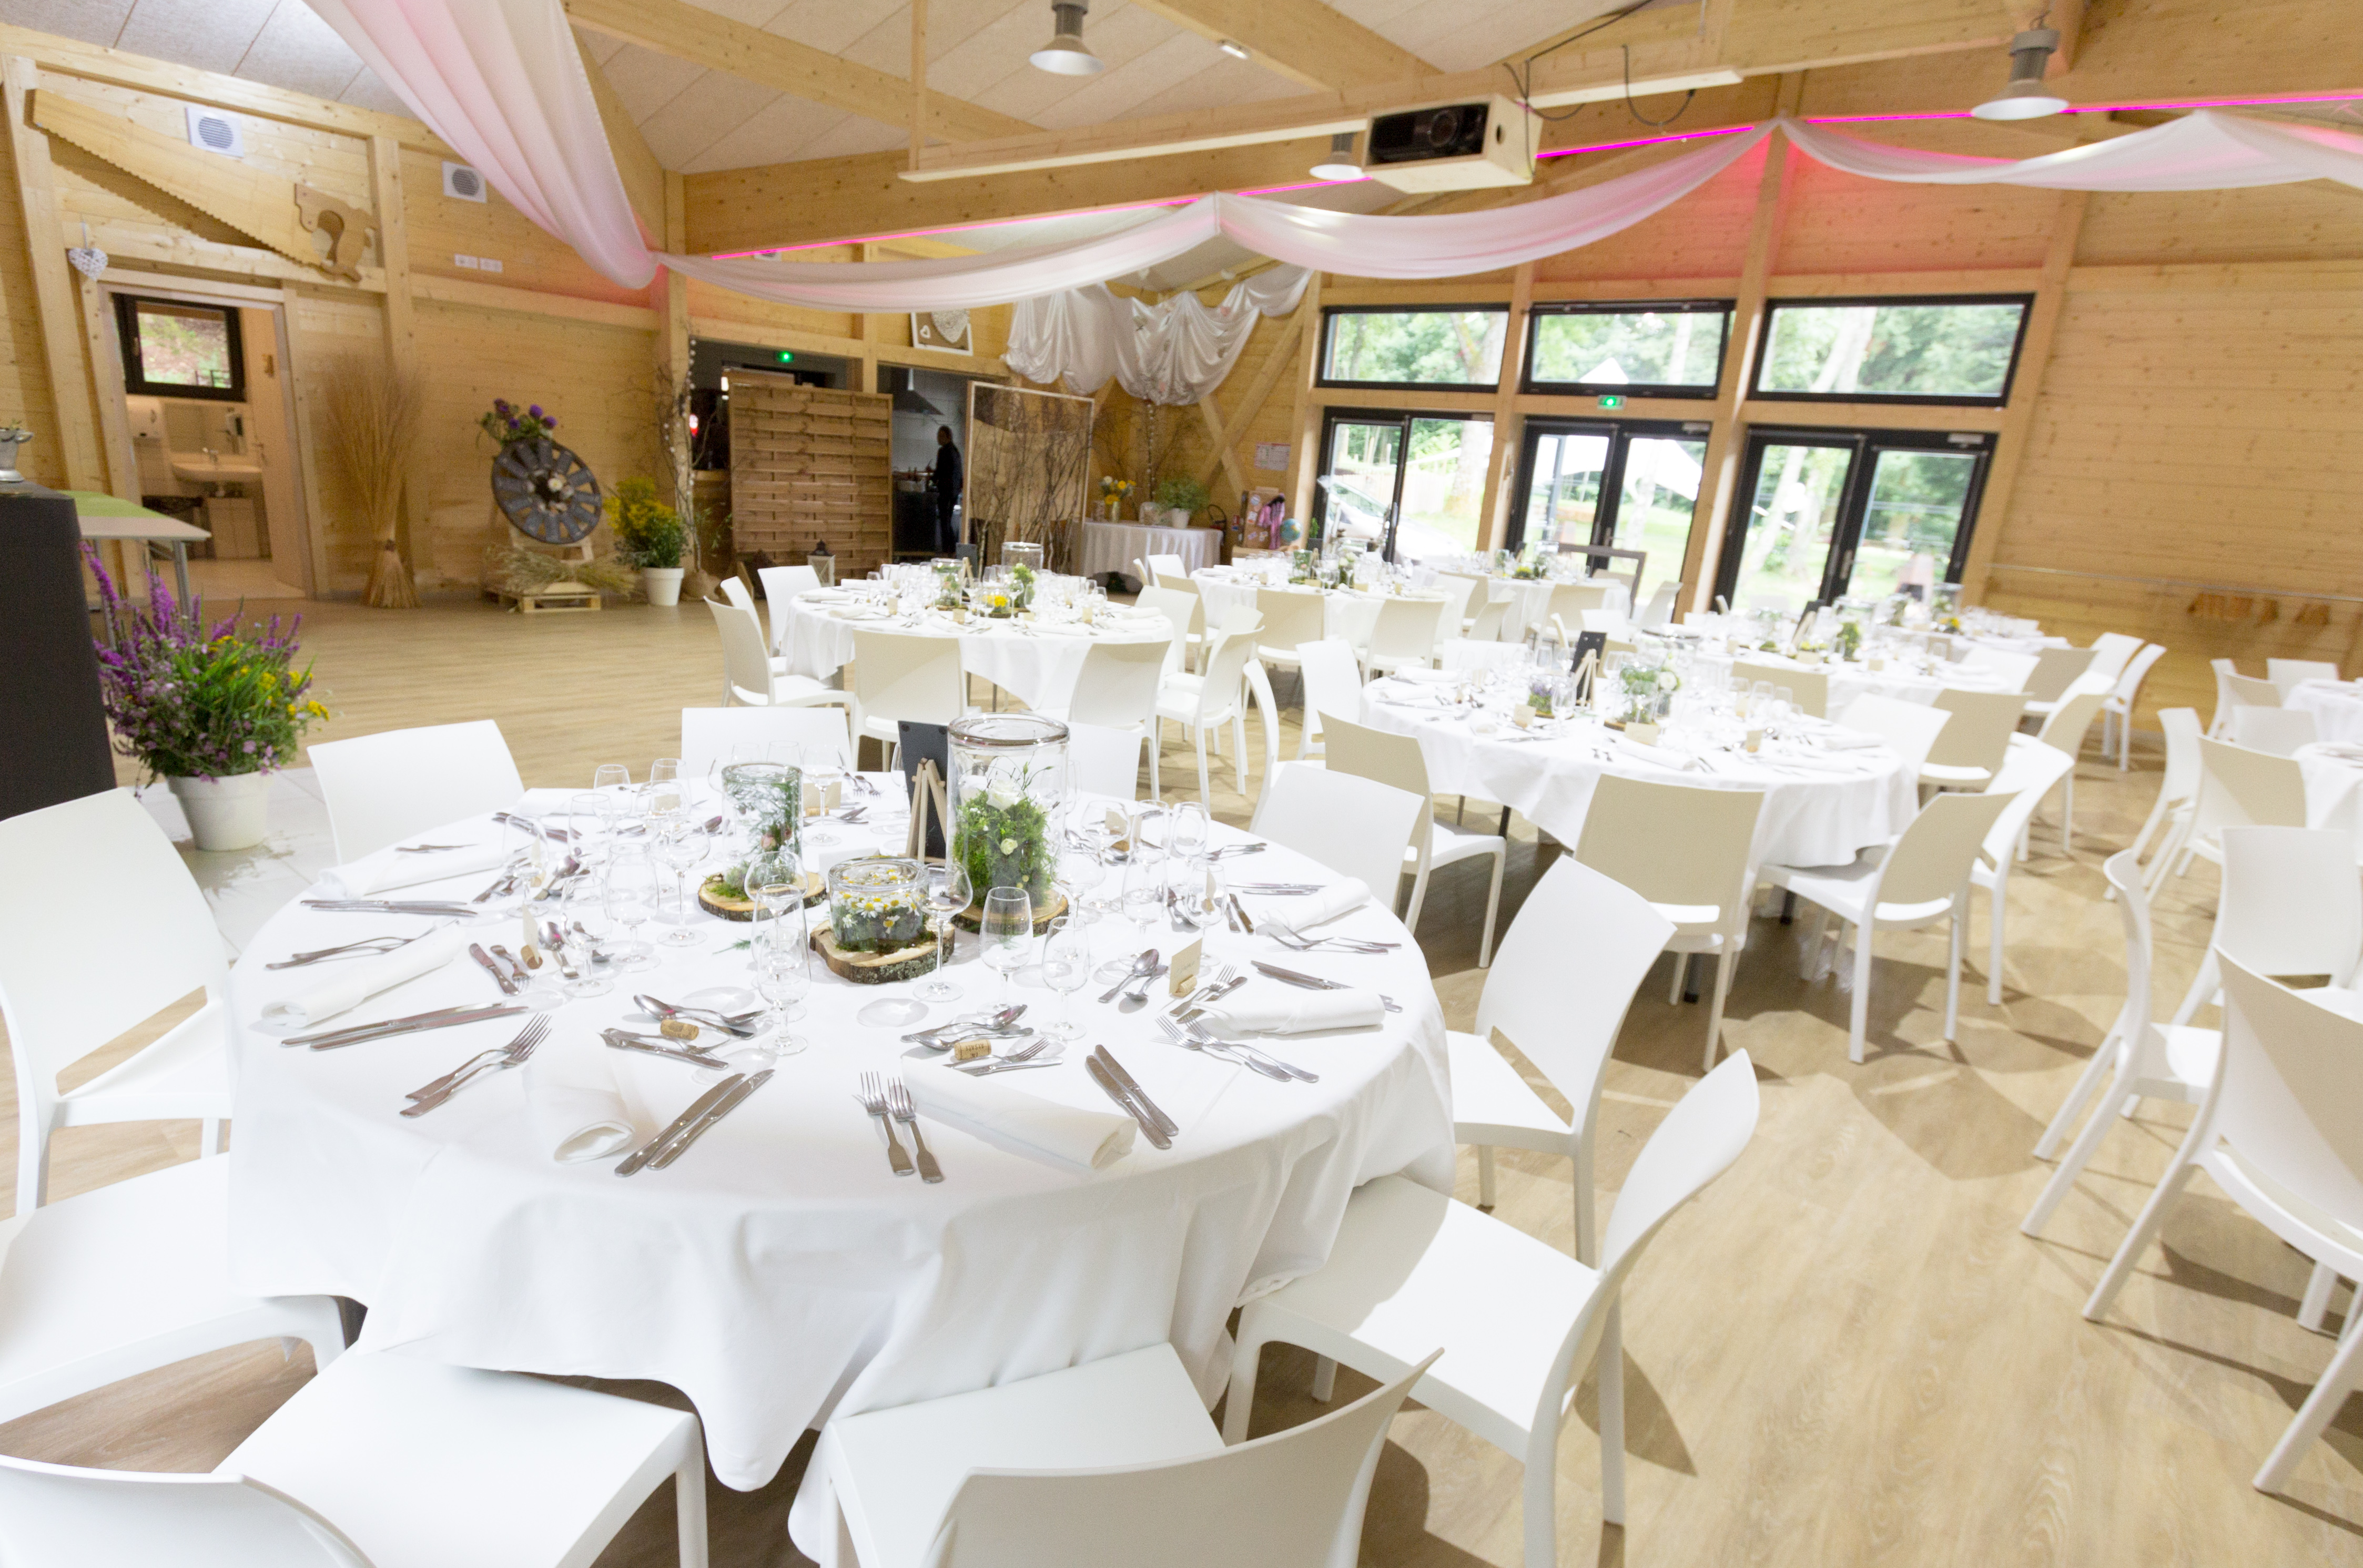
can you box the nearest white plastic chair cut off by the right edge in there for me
[2084,954,2363,1492]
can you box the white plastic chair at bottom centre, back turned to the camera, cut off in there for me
[820,1343,1437,1568]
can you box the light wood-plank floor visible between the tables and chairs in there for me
[18,605,2363,1568]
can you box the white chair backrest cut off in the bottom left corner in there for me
[0,1454,369,1568]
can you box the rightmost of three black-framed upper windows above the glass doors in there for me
[1753,295,2034,406]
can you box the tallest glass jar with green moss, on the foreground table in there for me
[945,713,1068,933]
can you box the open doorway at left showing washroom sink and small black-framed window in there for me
[102,279,312,600]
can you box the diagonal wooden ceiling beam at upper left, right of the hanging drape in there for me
[565,0,1035,141]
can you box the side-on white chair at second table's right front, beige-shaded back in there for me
[1763,788,2011,1063]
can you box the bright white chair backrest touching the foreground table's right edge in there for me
[1477,859,1673,1122]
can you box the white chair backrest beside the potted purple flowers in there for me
[310,718,524,864]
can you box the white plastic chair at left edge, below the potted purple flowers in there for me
[0,798,240,1209]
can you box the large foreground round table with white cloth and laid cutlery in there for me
[229,775,1453,1556]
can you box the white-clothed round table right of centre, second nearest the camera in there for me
[1361,680,1919,867]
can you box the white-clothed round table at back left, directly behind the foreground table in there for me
[780,588,1172,708]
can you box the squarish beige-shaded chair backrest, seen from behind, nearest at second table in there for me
[1578,772,1765,919]
